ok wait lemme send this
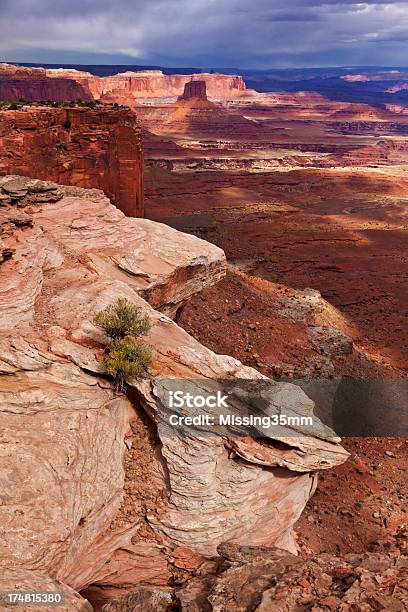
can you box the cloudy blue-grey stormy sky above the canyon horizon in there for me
[0,0,408,69]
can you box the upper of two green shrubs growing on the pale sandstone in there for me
[93,298,152,340]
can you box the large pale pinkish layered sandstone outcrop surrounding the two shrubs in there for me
[0,177,347,600]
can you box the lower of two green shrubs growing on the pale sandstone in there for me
[102,336,152,391]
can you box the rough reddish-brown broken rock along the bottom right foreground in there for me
[175,545,408,612]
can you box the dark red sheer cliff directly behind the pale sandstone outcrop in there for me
[0,106,143,217]
